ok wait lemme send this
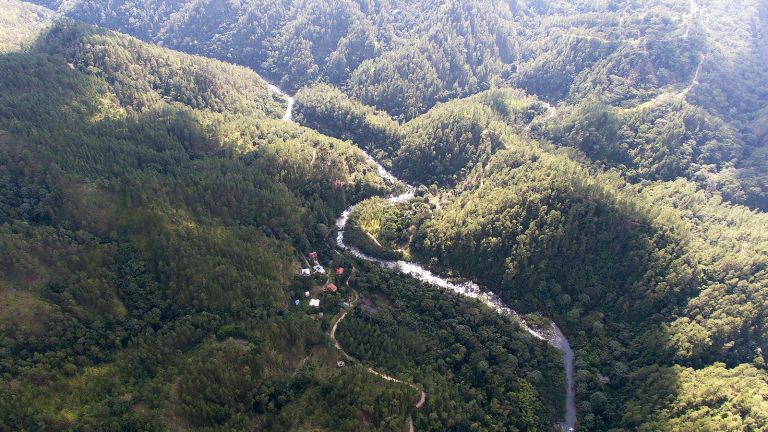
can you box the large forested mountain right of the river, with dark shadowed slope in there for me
[411,134,768,430]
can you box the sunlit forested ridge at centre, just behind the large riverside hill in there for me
[295,85,547,184]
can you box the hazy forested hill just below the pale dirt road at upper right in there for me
[541,101,768,209]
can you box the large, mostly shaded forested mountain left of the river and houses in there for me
[0,16,432,430]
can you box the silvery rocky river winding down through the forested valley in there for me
[269,84,576,432]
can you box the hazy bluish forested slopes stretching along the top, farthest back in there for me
[21,0,736,118]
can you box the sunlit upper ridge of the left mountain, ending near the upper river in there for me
[34,21,285,118]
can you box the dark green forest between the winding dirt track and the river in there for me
[338,265,563,431]
